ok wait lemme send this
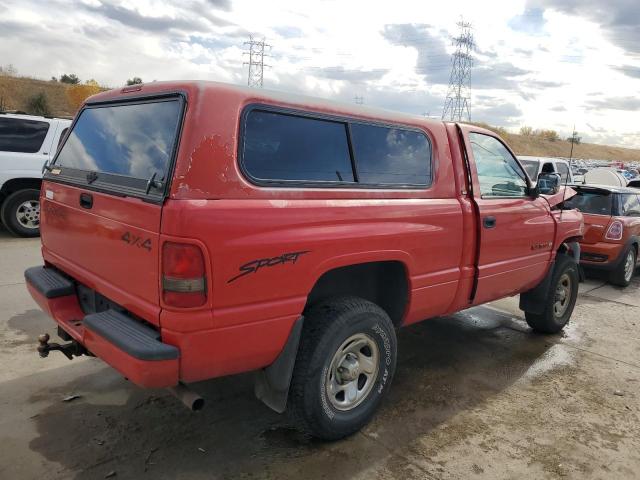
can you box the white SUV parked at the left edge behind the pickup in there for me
[0,113,71,237]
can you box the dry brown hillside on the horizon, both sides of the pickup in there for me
[0,75,640,162]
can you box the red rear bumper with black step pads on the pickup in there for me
[25,267,180,388]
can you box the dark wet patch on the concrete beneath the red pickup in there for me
[22,308,566,479]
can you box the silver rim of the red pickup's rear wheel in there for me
[325,333,380,411]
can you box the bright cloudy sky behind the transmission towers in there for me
[0,0,640,148]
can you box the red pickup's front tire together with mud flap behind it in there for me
[525,254,580,333]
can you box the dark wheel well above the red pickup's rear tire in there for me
[305,261,409,326]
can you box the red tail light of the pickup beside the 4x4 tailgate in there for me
[162,242,207,308]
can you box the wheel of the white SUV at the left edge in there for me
[0,188,40,237]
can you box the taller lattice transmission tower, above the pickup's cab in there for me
[442,20,475,122]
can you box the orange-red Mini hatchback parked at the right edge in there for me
[565,185,640,287]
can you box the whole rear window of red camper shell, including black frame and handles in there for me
[46,95,184,200]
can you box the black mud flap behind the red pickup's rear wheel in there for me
[254,316,304,413]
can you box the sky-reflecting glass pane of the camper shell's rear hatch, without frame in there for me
[55,98,181,181]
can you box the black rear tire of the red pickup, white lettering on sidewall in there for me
[289,297,397,440]
